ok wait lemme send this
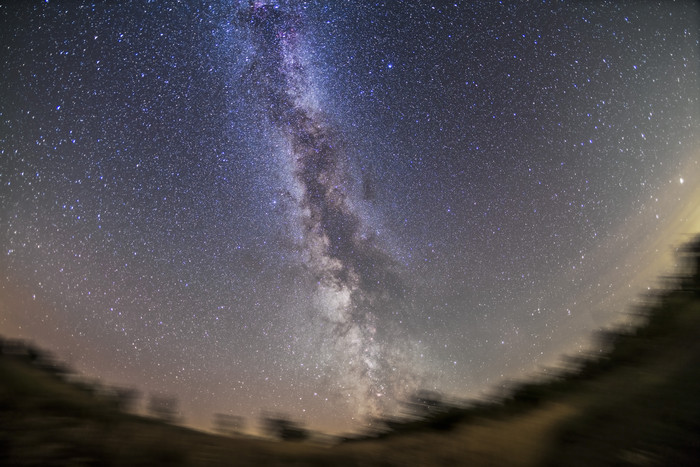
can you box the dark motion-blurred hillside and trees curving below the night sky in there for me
[0,237,700,466]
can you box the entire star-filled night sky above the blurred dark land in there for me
[0,0,700,432]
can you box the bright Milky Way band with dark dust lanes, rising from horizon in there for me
[241,4,418,421]
